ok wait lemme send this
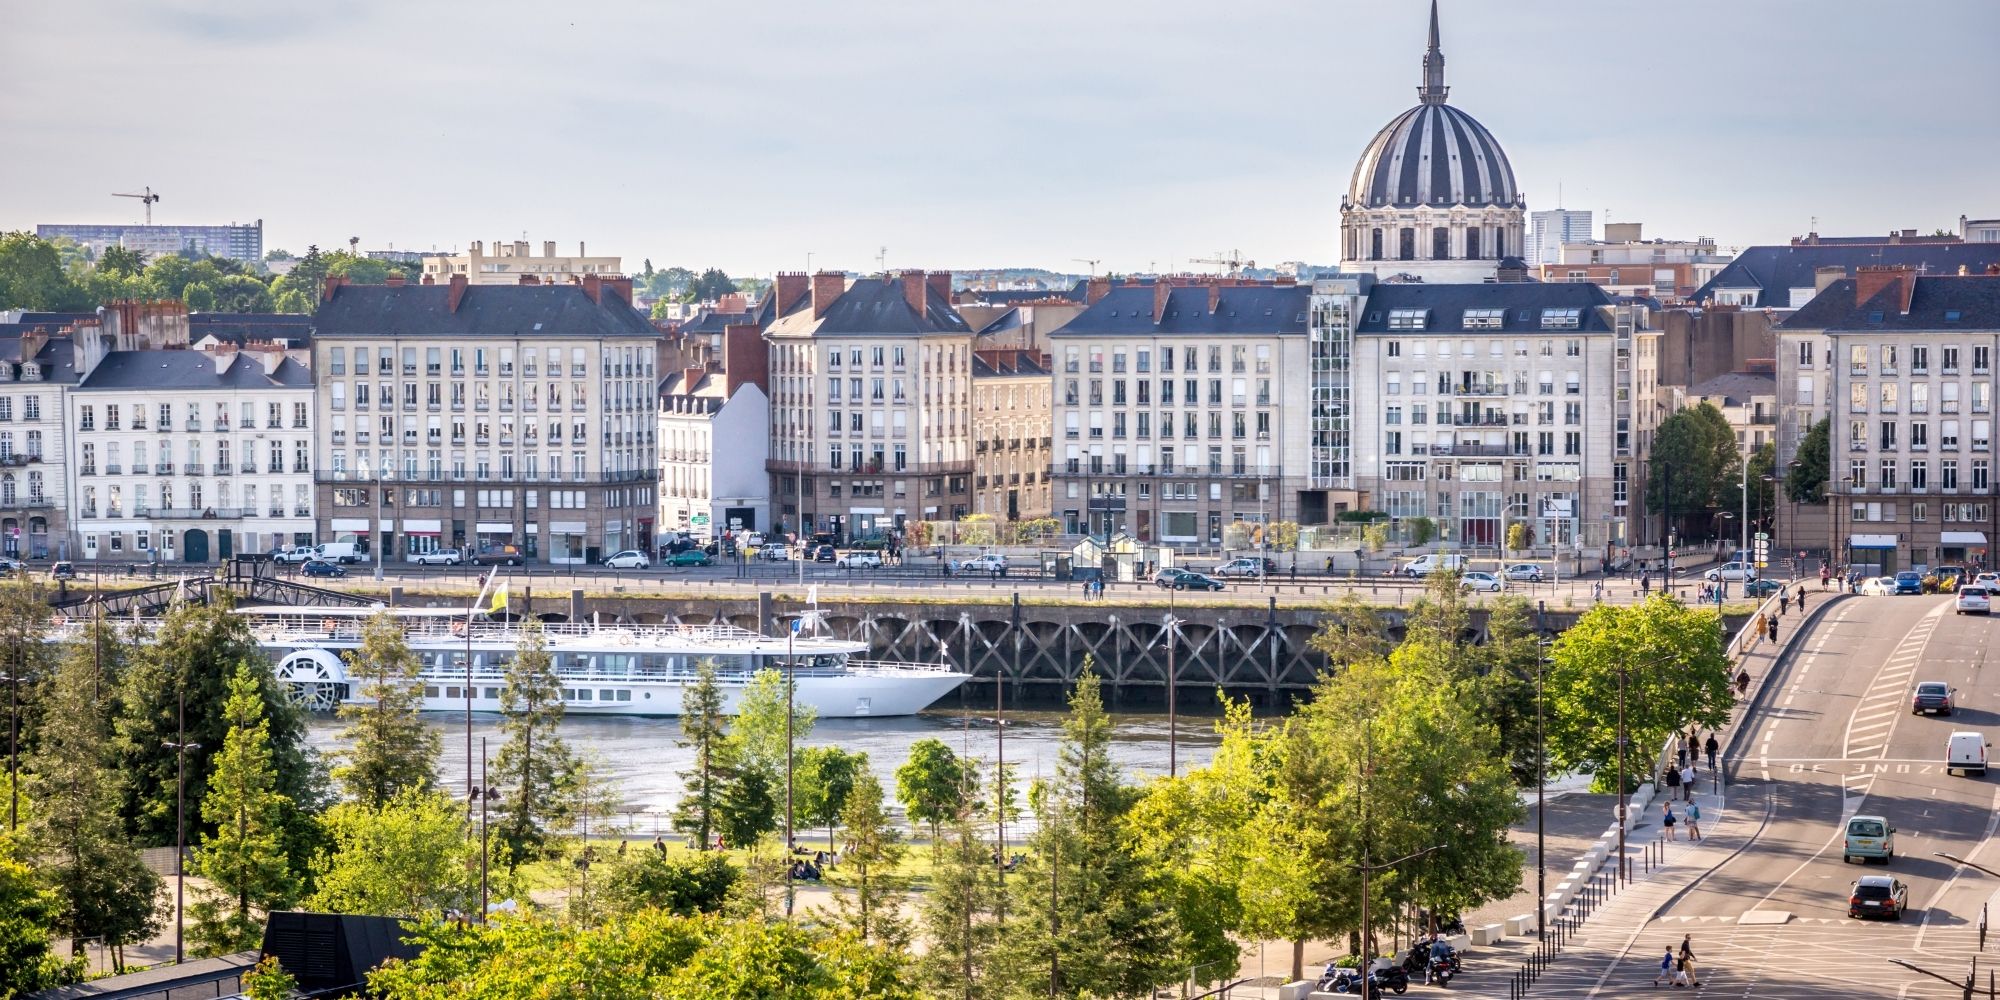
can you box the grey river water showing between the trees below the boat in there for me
[308,708,1216,836]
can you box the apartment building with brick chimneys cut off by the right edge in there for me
[1778,266,2000,572]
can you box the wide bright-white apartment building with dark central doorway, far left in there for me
[64,302,316,564]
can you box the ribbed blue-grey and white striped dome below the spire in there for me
[1348,98,1520,208]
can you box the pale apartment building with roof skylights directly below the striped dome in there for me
[1354,284,1630,550]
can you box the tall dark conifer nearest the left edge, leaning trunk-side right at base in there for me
[22,622,164,966]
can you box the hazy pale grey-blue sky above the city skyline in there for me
[0,0,2000,274]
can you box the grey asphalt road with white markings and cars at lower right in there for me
[1500,596,2000,998]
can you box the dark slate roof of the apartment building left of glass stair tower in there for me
[1048,284,1312,338]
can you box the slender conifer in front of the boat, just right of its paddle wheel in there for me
[334,610,442,806]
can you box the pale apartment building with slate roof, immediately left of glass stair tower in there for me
[1048,276,1312,544]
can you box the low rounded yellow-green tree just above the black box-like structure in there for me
[306,788,480,916]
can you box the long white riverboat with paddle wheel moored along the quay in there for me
[238,606,968,718]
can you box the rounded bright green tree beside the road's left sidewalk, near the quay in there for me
[1544,594,1734,788]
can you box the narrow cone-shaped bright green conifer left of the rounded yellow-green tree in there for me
[192,664,300,954]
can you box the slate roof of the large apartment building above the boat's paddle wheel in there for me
[312,284,662,338]
